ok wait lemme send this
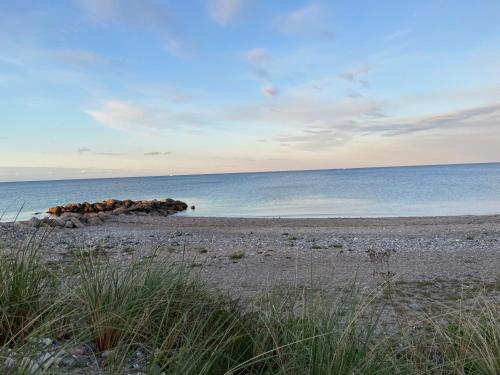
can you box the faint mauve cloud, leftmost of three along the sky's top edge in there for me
[80,0,170,29]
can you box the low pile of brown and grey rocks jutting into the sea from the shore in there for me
[30,198,188,228]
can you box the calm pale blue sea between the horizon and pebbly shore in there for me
[0,163,500,221]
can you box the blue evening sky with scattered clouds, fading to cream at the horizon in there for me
[0,0,500,181]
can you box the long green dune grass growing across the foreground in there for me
[0,236,500,374]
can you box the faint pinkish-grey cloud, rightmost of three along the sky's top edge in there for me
[279,2,333,39]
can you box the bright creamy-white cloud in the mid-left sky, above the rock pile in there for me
[87,100,157,130]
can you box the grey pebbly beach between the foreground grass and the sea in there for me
[0,215,500,308]
